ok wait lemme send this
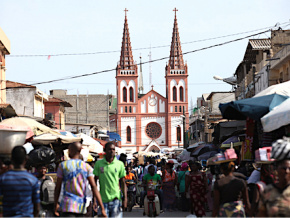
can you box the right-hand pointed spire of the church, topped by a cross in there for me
[169,8,184,69]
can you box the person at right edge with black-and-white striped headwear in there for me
[258,137,290,217]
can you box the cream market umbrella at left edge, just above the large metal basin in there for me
[0,117,60,138]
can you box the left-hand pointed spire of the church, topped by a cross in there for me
[120,8,134,70]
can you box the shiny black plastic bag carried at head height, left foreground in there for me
[27,146,56,167]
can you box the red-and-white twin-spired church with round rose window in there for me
[111,9,189,152]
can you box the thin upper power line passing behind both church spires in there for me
[7,21,289,58]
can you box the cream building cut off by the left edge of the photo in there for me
[0,27,10,104]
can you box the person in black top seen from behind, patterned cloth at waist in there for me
[212,160,250,217]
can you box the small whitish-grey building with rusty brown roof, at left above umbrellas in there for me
[6,80,48,119]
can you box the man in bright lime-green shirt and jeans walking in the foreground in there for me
[94,142,127,217]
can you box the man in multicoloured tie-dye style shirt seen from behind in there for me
[54,142,106,217]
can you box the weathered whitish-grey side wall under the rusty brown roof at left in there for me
[6,88,36,117]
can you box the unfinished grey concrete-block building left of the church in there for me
[50,89,113,135]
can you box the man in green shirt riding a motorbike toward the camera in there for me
[140,165,163,210]
